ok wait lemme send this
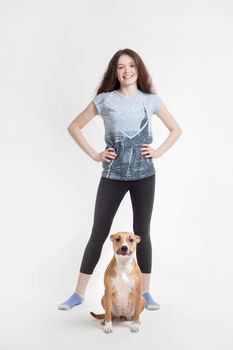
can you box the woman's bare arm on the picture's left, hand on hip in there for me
[67,101,117,162]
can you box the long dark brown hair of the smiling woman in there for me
[93,48,156,95]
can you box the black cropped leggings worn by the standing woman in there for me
[80,174,155,274]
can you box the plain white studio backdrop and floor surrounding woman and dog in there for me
[0,0,233,350]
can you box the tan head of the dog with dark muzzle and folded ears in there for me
[110,232,141,256]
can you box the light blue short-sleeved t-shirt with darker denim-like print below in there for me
[93,90,161,181]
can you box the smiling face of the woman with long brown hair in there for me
[116,54,138,87]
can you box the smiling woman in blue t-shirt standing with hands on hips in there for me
[58,49,182,310]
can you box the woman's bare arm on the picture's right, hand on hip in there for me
[141,102,182,158]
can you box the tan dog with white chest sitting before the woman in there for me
[90,232,146,333]
